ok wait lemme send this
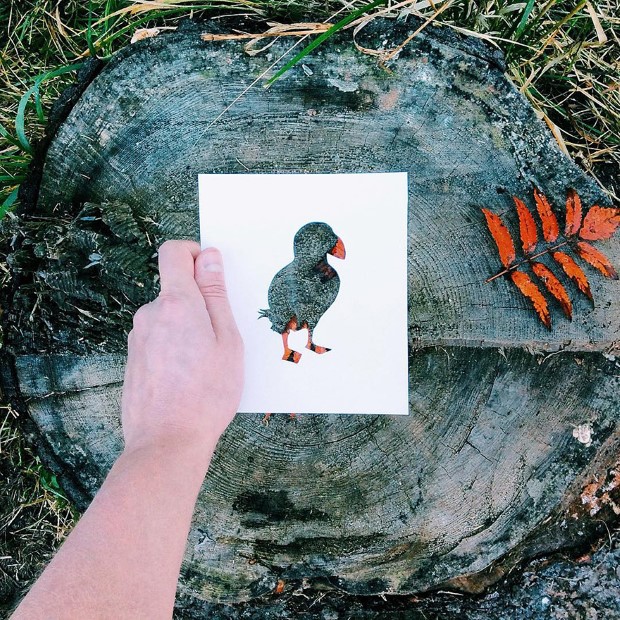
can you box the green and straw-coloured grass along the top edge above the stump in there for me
[0,0,620,217]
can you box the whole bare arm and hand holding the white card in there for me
[12,241,243,620]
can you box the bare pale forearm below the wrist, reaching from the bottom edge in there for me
[13,440,216,620]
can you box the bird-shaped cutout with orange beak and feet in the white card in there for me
[258,222,346,364]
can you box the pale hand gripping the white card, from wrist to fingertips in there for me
[122,241,243,456]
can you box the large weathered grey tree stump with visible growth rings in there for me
[2,21,620,602]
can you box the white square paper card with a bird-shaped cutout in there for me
[199,173,409,415]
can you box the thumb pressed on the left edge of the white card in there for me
[195,248,237,338]
